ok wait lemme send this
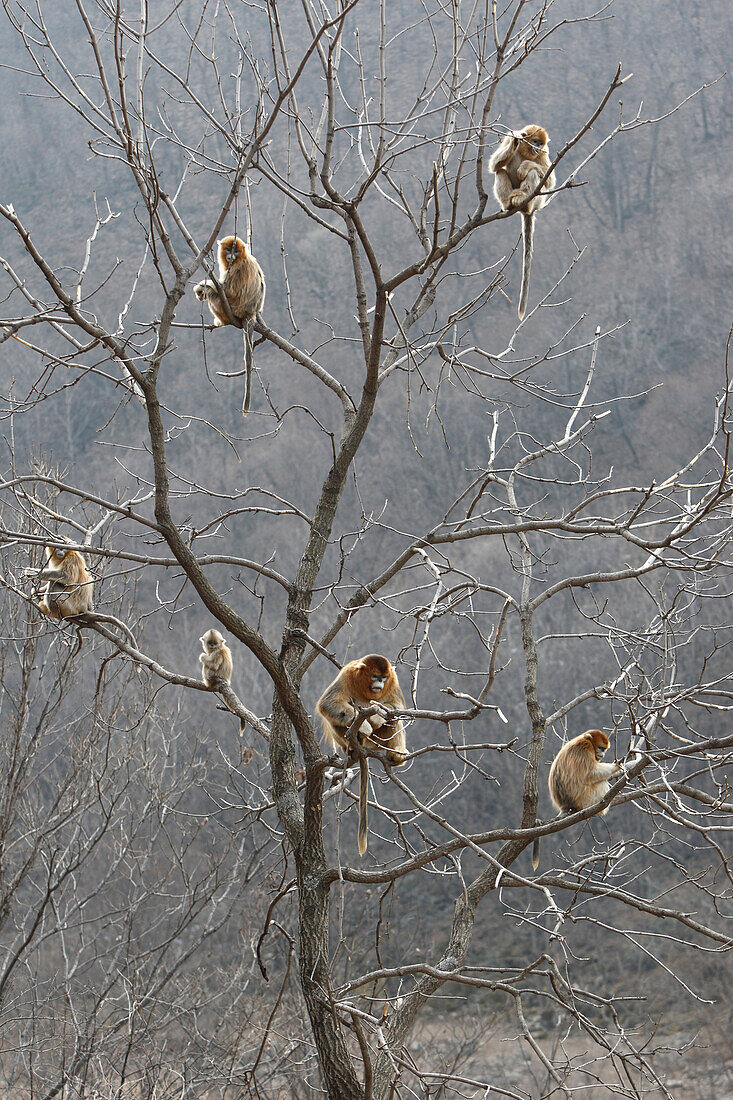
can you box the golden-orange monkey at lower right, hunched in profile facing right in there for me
[532,729,623,869]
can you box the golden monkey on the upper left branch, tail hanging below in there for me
[194,237,265,416]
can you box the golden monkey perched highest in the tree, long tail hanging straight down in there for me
[489,125,555,320]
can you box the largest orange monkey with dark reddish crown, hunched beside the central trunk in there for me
[316,653,407,856]
